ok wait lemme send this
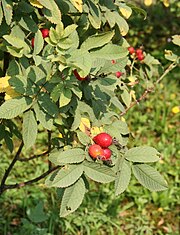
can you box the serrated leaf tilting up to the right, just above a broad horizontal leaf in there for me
[81,32,114,50]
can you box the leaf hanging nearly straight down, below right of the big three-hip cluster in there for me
[115,160,131,196]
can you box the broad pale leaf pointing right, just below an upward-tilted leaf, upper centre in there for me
[90,44,128,60]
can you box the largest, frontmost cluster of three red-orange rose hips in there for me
[88,132,113,161]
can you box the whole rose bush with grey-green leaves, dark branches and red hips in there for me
[0,0,179,217]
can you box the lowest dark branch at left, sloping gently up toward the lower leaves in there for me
[1,166,60,193]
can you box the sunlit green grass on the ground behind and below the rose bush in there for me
[0,73,180,235]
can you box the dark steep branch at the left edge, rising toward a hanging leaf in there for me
[0,142,24,194]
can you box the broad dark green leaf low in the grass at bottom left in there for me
[27,201,48,223]
